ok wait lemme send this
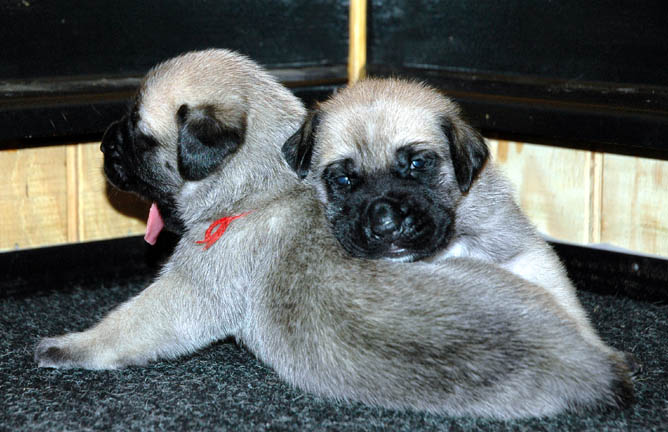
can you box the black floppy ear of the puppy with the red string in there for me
[176,105,246,180]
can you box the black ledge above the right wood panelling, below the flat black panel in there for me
[367,64,668,159]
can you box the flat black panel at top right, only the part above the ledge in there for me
[368,0,668,86]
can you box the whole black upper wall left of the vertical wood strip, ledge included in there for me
[0,0,348,142]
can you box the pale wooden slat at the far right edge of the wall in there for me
[601,154,668,256]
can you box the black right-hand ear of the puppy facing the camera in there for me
[441,119,489,193]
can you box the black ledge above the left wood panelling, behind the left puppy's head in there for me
[0,65,346,146]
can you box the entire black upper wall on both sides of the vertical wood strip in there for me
[0,0,668,154]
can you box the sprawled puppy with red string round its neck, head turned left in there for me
[35,50,633,419]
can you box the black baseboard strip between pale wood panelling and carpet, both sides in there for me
[0,233,668,304]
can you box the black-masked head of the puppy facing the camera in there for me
[283,79,488,261]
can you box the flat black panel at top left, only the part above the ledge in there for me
[0,0,348,81]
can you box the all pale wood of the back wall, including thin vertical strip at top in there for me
[0,0,668,256]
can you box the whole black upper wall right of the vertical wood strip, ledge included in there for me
[368,0,668,154]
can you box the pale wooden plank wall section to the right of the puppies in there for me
[488,140,668,256]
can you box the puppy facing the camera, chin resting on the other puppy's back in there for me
[283,79,631,360]
